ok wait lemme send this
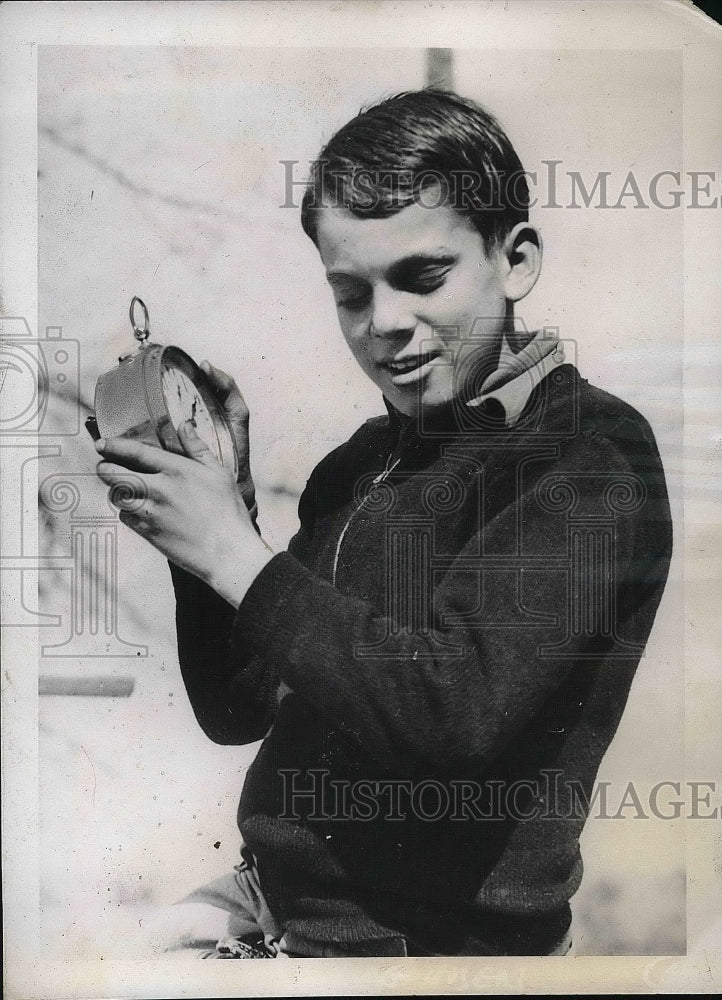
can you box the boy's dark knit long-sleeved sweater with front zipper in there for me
[172,365,671,955]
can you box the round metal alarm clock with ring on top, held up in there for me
[86,296,238,477]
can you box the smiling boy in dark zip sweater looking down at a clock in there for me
[98,90,671,957]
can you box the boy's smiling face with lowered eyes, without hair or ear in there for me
[317,199,508,416]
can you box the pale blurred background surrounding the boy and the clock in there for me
[38,46,685,958]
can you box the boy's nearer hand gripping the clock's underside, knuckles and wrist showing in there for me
[95,421,273,607]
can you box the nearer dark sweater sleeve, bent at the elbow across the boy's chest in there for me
[233,436,668,774]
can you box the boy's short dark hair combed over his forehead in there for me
[301,88,529,251]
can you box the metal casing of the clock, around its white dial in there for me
[94,342,238,478]
